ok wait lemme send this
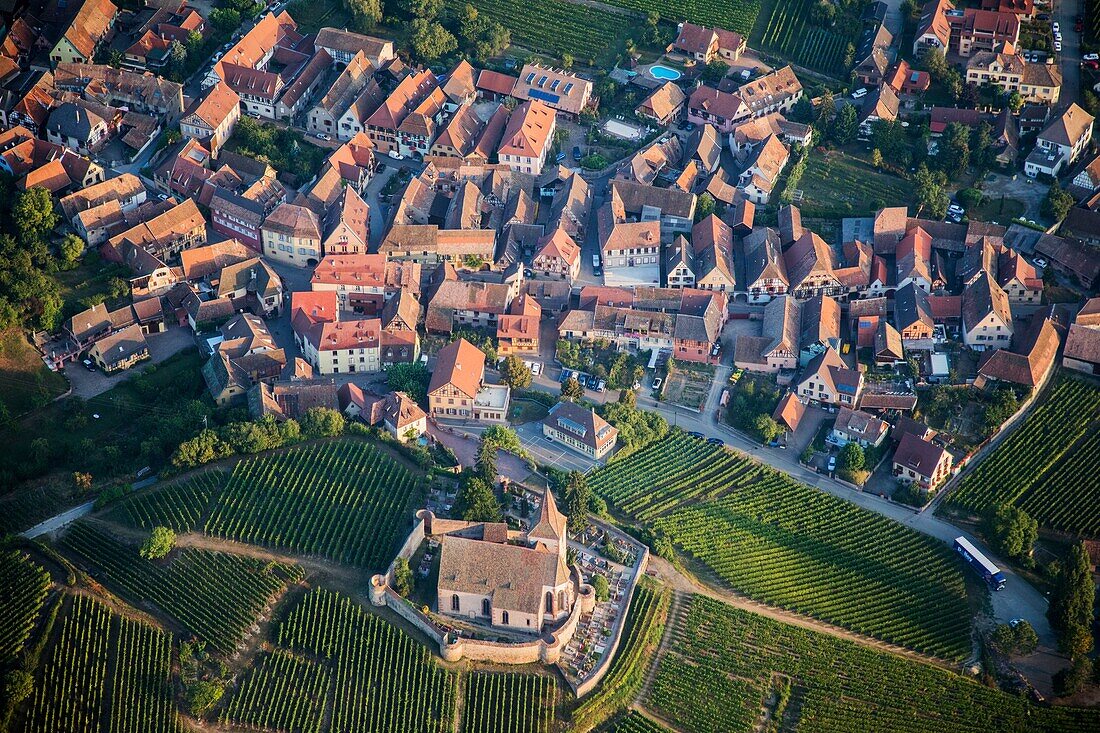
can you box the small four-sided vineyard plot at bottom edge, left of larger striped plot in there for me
[221,650,329,733]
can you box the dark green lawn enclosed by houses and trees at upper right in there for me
[799,150,913,218]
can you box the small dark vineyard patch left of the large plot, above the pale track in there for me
[109,471,226,532]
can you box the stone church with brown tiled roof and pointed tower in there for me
[436,491,576,635]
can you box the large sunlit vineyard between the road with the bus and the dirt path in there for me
[590,431,970,659]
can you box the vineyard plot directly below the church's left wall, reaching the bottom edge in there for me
[275,589,455,733]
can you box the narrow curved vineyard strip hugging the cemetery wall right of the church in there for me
[573,578,672,731]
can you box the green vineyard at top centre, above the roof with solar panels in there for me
[447,0,629,63]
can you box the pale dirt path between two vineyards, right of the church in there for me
[647,555,958,669]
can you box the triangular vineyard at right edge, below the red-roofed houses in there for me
[947,376,1100,536]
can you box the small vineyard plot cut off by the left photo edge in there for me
[0,550,50,670]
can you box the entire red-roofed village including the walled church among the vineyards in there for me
[0,0,1100,730]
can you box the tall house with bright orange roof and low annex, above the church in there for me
[428,338,509,423]
